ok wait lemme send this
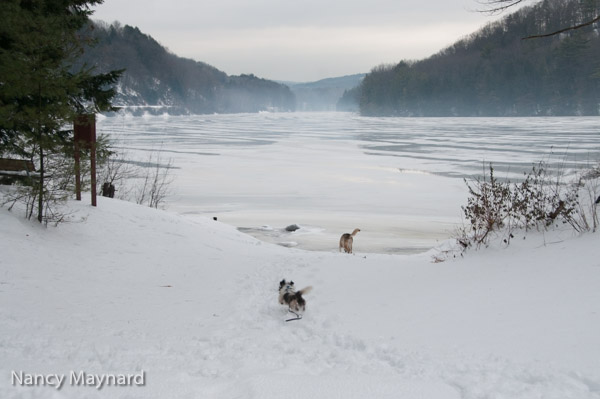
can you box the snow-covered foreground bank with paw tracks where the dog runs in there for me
[0,198,600,399]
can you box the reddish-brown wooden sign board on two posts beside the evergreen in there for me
[73,114,96,206]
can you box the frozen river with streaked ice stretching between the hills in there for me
[97,113,600,254]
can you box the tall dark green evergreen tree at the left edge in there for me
[0,0,121,222]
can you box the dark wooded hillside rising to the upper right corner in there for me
[356,0,600,116]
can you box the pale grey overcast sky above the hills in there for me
[92,0,508,82]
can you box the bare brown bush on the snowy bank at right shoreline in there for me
[455,162,600,249]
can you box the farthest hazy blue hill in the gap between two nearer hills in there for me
[285,73,365,111]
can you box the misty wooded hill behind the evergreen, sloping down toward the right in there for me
[81,22,296,114]
